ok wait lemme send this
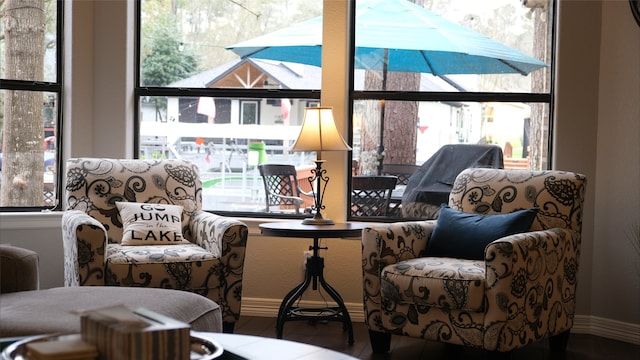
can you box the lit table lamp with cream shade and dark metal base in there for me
[291,107,351,225]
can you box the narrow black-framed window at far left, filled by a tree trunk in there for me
[0,0,63,211]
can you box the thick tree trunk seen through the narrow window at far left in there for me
[0,0,45,206]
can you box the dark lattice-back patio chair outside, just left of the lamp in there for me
[258,164,313,214]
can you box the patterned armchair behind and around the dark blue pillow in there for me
[362,168,586,353]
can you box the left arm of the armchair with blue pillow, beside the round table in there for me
[362,220,436,329]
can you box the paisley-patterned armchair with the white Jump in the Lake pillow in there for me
[62,158,248,332]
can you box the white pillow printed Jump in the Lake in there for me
[116,202,189,245]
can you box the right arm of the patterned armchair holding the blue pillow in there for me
[484,228,580,351]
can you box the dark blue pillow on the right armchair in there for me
[427,204,538,260]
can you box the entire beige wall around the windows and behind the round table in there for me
[0,0,640,343]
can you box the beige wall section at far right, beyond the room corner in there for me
[591,1,640,324]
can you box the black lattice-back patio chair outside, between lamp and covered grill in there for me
[351,175,398,216]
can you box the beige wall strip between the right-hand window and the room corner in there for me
[552,1,602,320]
